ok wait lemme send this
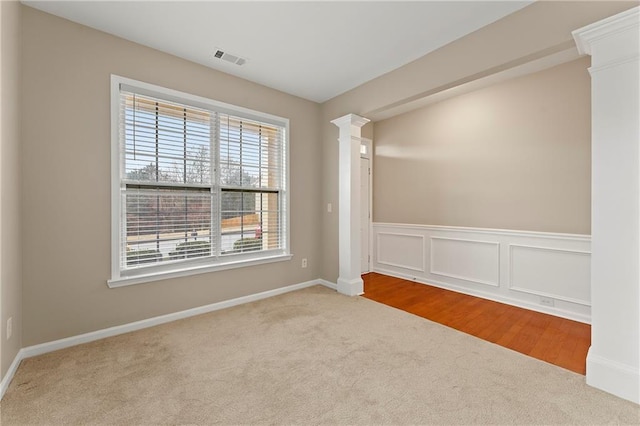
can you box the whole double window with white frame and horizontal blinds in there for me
[109,76,291,287]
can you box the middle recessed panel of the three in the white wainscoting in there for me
[429,237,500,287]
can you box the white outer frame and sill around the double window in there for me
[107,74,293,288]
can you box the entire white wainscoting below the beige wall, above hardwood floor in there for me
[372,222,591,323]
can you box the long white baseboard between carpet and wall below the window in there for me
[0,279,336,400]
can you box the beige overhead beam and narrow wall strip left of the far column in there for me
[322,1,638,282]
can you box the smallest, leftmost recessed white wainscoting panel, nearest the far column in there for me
[376,232,424,272]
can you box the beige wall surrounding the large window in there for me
[22,7,321,346]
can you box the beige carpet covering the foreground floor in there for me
[0,286,640,426]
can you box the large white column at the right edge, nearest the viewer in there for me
[573,7,640,403]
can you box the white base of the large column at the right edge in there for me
[587,348,640,404]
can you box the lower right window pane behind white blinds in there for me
[220,190,281,254]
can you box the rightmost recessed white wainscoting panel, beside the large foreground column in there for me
[509,244,591,306]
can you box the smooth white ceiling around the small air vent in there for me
[23,0,532,102]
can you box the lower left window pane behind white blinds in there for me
[121,188,215,268]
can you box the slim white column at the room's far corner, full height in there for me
[332,114,369,296]
